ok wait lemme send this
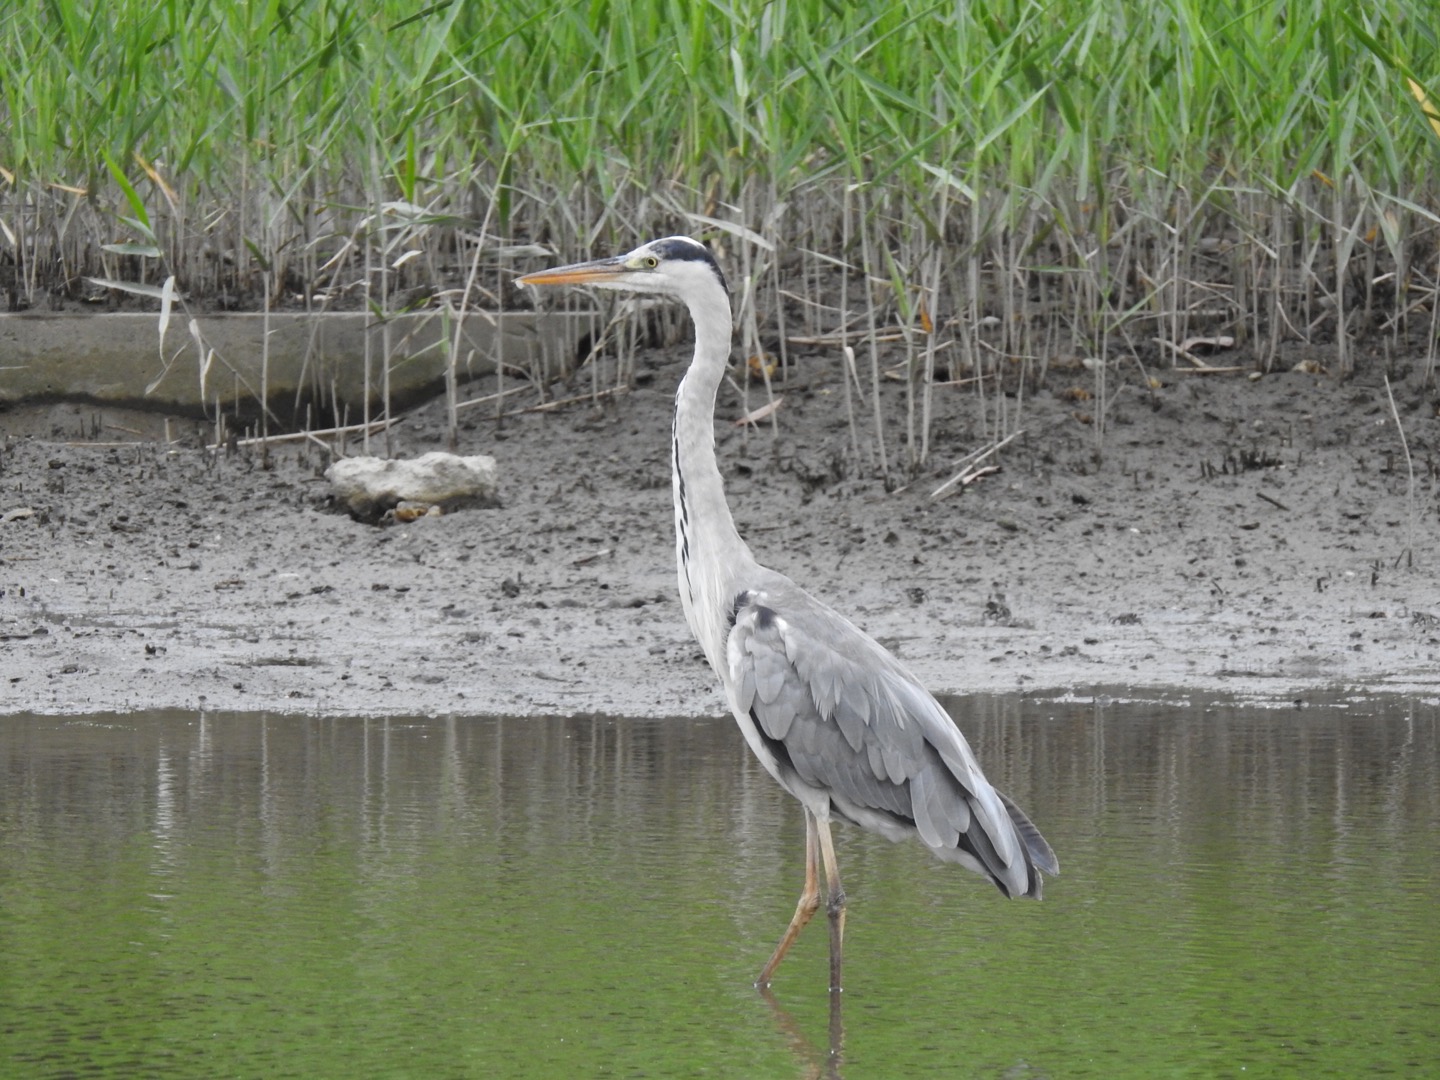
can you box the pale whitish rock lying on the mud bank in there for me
[325,451,497,518]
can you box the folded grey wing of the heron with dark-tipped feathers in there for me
[727,587,1058,897]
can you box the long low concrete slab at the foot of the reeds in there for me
[0,311,593,423]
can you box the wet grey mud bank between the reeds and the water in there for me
[0,347,1440,714]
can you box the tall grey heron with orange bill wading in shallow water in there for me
[520,236,1060,991]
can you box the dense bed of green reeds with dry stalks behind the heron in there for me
[0,0,1440,475]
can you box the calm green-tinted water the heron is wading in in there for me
[0,698,1440,1079]
